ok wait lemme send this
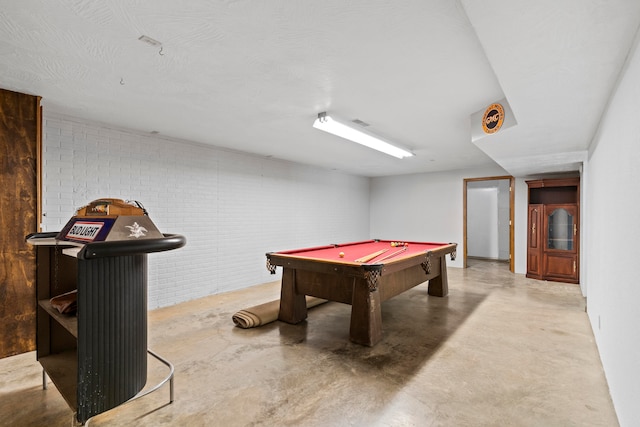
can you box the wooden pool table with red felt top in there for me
[266,240,457,346]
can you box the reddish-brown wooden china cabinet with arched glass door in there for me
[527,178,580,283]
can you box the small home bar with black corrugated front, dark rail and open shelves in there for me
[27,200,186,424]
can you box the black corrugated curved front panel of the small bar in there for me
[77,254,147,423]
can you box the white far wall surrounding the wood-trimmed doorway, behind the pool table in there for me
[370,166,510,267]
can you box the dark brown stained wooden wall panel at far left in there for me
[0,89,40,357]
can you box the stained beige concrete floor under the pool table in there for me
[0,260,618,426]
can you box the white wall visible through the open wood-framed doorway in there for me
[467,187,498,259]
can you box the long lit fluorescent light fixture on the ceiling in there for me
[313,113,413,159]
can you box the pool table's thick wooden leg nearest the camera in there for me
[349,278,382,346]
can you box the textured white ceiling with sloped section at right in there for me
[0,0,640,176]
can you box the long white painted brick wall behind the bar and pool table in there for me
[42,111,369,308]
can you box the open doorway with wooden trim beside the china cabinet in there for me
[463,176,515,273]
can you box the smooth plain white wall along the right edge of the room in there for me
[581,27,640,426]
